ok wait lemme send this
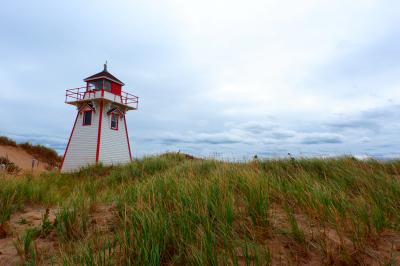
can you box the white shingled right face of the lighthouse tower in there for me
[99,104,130,164]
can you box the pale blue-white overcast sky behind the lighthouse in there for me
[0,0,400,159]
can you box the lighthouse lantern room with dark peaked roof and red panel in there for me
[83,64,125,95]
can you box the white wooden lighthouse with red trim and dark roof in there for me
[61,64,138,172]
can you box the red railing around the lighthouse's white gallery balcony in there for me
[65,87,139,109]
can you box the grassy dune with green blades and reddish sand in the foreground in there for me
[0,153,400,265]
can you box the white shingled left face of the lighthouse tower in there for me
[61,102,100,172]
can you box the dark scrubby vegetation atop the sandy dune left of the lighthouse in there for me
[0,136,62,168]
